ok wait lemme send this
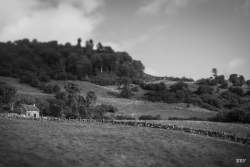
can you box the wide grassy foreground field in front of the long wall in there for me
[0,118,250,167]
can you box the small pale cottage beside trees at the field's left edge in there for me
[20,104,40,118]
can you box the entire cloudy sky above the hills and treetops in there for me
[0,0,250,79]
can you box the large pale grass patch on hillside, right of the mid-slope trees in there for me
[99,98,216,119]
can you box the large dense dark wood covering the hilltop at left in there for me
[0,39,144,87]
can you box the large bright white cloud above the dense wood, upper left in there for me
[0,0,103,42]
